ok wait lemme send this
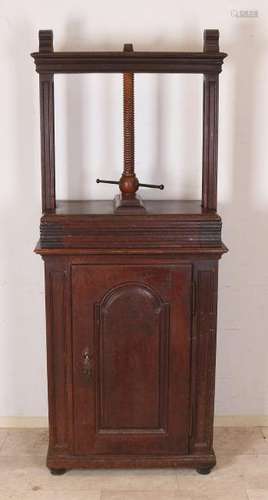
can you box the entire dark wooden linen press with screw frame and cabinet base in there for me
[32,30,227,474]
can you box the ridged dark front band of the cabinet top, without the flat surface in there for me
[40,218,222,251]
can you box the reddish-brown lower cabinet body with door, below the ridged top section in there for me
[42,254,218,471]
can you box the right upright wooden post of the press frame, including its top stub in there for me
[202,30,219,210]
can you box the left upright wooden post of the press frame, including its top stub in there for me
[39,30,56,213]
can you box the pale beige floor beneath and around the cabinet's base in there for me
[0,427,268,500]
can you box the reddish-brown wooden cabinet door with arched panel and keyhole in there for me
[72,264,191,455]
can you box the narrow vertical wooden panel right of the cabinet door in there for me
[192,262,218,453]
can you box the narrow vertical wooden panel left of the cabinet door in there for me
[46,264,71,452]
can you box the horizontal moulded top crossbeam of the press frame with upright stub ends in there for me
[31,30,227,74]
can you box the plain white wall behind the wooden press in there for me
[0,0,268,416]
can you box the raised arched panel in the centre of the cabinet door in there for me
[96,283,169,431]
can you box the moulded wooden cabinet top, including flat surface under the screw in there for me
[36,200,226,257]
